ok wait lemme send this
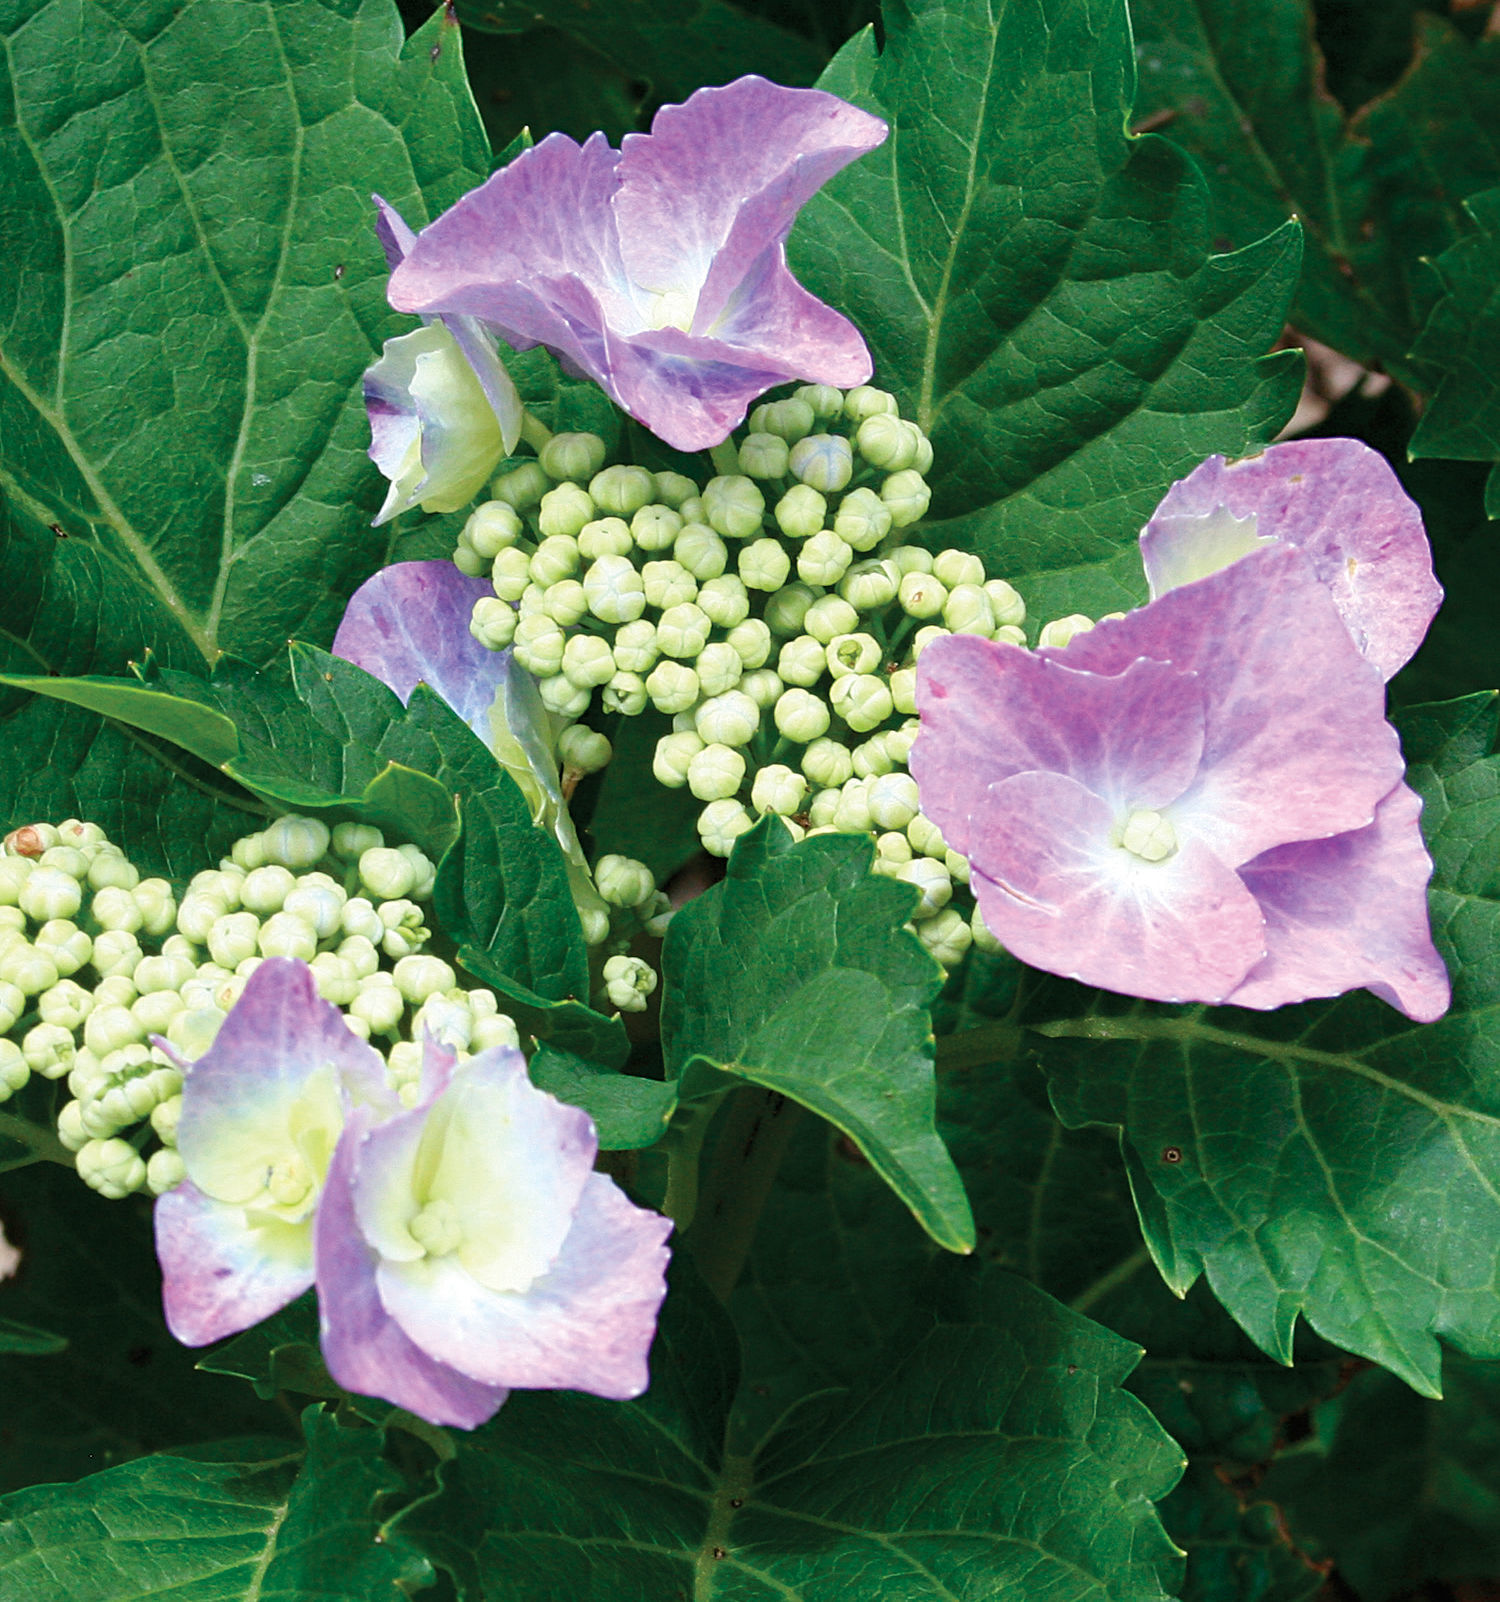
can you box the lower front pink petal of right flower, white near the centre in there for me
[971,772,1266,1001]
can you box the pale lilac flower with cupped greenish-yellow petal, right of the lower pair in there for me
[317,1040,671,1429]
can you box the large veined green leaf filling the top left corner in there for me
[0,0,489,671]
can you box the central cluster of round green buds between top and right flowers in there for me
[454,384,1093,974]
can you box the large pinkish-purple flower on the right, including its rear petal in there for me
[912,441,1449,1020]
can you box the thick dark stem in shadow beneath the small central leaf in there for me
[688,1085,801,1302]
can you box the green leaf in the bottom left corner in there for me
[0,1408,428,1602]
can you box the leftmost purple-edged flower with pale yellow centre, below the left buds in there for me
[155,956,401,1346]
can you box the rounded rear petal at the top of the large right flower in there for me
[1141,439,1442,679]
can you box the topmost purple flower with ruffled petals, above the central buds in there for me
[381,77,886,450]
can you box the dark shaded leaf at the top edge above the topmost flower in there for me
[457,0,824,100]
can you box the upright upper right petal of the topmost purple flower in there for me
[614,77,886,333]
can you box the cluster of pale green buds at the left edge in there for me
[0,817,518,1198]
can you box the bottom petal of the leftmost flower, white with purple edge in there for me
[154,1181,313,1346]
